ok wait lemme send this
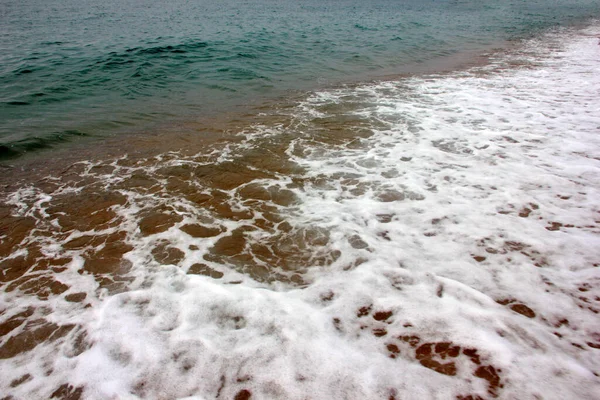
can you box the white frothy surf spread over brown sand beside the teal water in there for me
[0,28,600,399]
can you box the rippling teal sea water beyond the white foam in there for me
[0,0,600,159]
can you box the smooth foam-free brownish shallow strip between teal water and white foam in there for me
[0,30,536,192]
